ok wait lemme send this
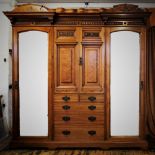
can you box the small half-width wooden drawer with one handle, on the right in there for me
[80,94,104,102]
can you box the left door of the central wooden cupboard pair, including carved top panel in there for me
[55,29,79,92]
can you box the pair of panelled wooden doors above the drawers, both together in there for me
[55,28,104,93]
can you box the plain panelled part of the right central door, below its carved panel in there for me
[81,45,103,92]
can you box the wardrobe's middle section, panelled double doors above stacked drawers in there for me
[54,27,104,141]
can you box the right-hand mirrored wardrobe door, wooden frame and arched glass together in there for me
[106,27,146,138]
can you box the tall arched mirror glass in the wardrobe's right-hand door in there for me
[110,31,140,136]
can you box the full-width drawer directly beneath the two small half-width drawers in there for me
[54,102,104,113]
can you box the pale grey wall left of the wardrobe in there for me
[0,4,11,131]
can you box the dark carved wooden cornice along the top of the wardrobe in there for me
[4,4,150,26]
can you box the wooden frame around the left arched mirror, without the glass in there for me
[12,26,53,140]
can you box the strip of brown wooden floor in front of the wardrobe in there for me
[0,149,155,155]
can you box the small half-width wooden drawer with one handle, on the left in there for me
[54,94,79,103]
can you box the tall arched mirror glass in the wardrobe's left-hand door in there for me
[19,31,48,136]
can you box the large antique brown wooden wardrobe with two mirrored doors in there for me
[4,4,150,149]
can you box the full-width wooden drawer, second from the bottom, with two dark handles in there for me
[54,112,104,126]
